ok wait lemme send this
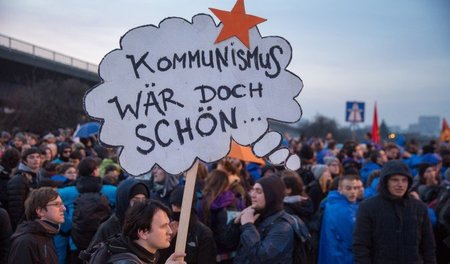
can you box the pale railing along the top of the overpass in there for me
[0,34,98,73]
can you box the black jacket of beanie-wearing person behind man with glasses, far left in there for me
[7,163,37,230]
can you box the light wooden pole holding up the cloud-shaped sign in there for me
[175,160,198,261]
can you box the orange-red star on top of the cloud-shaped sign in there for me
[209,0,267,48]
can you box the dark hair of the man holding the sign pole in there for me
[122,200,170,240]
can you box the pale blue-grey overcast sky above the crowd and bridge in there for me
[0,0,450,128]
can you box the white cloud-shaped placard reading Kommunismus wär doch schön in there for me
[84,14,303,175]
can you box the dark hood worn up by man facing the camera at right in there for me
[379,160,413,199]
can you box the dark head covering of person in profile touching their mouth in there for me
[256,174,285,218]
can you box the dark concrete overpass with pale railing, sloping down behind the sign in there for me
[0,34,298,136]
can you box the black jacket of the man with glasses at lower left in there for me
[8,220,59,264]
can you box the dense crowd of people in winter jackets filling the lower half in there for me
[0,129,450,264]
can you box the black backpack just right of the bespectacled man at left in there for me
[71,192,111,250]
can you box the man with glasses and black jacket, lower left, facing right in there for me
[8,187,66,264]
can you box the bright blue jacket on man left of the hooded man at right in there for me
[318,191,358,264]
